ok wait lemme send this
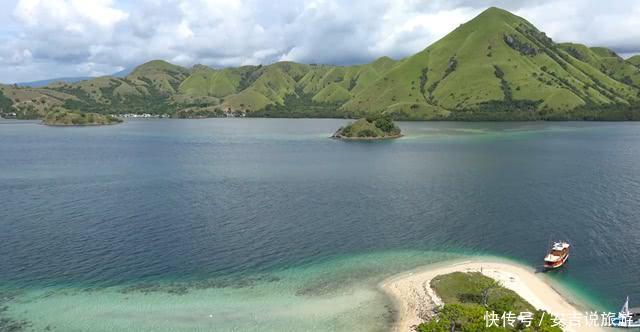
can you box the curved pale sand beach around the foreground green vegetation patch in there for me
[380,259,604,332]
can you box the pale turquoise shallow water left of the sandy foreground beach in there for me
[3,251,464,331]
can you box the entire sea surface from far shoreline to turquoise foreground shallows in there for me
[0,119,640,331]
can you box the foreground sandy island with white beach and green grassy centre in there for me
[380,258,602,332]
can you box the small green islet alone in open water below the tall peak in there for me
[331,115,402,140]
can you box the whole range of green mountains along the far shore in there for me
[0,7,640,120]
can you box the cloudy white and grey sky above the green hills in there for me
[0,0,640,83]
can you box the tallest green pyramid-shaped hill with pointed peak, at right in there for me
[343,8,638,116]
